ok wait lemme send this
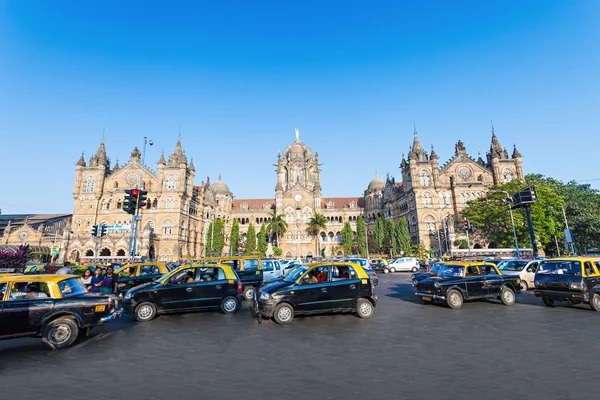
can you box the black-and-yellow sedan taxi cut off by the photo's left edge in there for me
[0,275,122,349]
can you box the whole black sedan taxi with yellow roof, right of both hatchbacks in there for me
[415,261,521,309]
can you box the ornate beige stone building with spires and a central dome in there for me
[2,126,524,261]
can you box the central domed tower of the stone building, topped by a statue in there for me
[275,129,322,257]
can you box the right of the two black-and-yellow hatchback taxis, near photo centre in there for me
[253,262,377,324]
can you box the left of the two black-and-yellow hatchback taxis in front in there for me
[123,264,242,322]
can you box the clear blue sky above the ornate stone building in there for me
[0,0,600,214]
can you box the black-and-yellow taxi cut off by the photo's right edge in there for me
[533,257,600,311]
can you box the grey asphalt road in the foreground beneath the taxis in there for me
[0,273,600,400]
